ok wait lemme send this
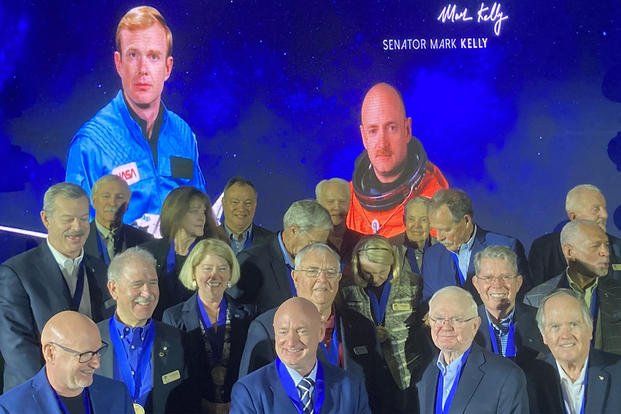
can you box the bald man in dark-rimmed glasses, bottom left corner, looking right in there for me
[0,311,134,414]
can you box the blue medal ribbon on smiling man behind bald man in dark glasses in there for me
[109,318,155,401]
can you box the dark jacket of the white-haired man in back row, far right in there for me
[528,232,621,286]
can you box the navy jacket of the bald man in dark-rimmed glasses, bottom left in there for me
[0,368,134,414]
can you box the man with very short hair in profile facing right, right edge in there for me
[524,220,621,355]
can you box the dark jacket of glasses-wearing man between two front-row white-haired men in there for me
[474,302,548,367]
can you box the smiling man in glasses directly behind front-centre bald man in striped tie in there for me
[239,243,388,412]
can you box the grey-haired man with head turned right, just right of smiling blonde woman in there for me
[232,200,332,314]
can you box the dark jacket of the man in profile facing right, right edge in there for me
[524,272,621,355]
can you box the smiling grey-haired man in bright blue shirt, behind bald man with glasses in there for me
[98,247,200,414]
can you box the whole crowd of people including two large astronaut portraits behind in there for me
[0,6,621,414]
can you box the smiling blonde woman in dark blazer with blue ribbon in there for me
[163,239,254,414]
